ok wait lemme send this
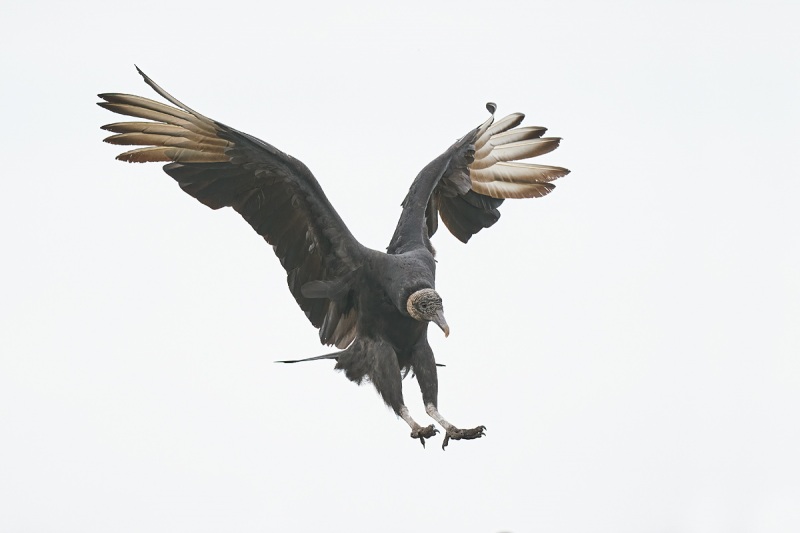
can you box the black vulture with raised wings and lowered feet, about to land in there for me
[98,67,569,448]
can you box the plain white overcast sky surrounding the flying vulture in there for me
[0,1,800,533]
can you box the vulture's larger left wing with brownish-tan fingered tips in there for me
[98,67,363,348]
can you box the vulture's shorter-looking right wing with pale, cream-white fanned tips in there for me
[389,103,569,253]
